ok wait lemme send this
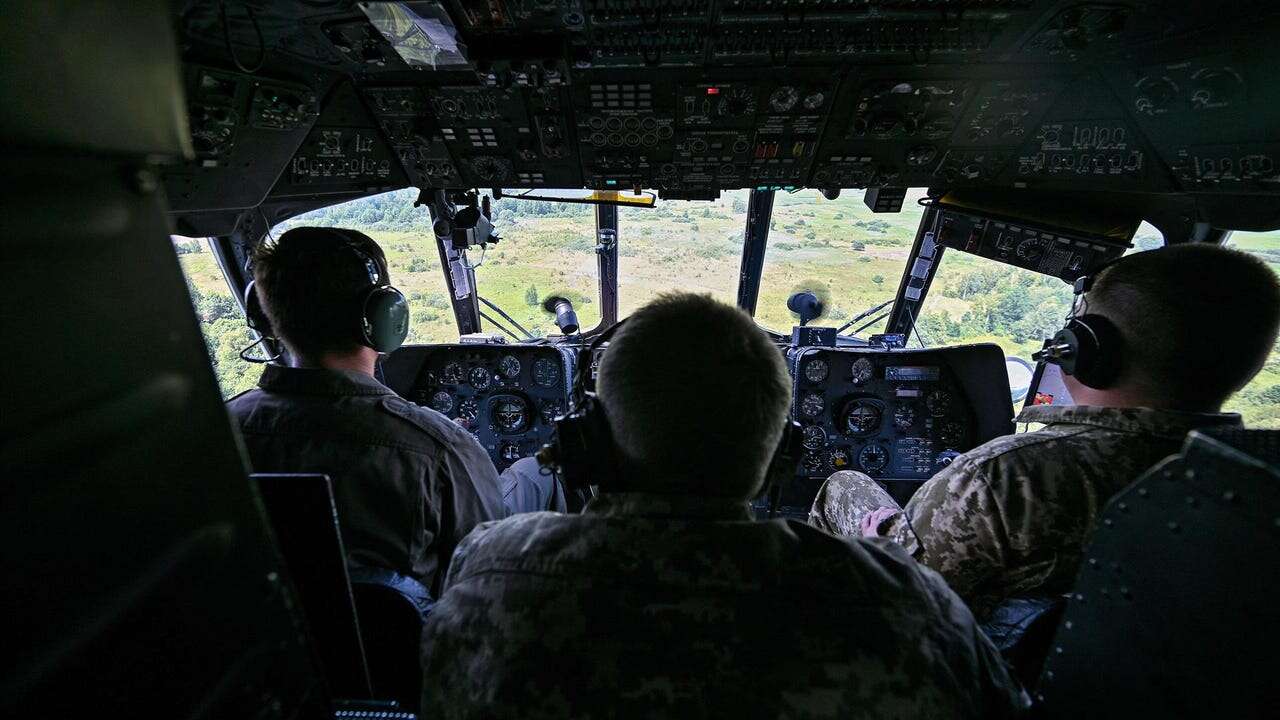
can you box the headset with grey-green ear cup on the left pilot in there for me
[244,228,408,352]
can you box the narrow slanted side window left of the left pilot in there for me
[172,236,260,398]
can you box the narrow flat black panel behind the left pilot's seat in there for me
[251,473,373,707]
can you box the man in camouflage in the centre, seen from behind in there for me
[422,295,1027,719]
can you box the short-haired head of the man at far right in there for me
[1084,243,1280,410]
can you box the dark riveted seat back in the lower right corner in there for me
[1037,429,1280,719]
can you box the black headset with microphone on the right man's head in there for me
[1032,263,1124,389]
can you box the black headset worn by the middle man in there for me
[538,320,804,497]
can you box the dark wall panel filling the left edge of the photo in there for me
[0,0,326,717]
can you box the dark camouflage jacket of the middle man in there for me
[422,493,1025,719]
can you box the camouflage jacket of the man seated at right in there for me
[819,406,1240,618]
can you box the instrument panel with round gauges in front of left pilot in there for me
[397,345,573,471]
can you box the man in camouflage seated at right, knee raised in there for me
[809,245,1280,619]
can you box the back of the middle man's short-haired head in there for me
[598,293,791,498]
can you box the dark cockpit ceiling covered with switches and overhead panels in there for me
[168,0,1280,211]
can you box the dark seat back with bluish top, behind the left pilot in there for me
[351,568,435,707]
